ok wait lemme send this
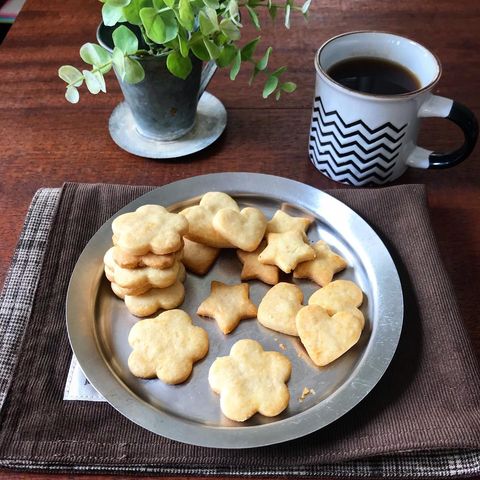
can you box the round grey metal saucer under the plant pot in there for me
[108,92,227,158]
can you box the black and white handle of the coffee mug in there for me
[407,95,478,169]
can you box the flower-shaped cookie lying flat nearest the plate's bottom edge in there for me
[208,339,292,422]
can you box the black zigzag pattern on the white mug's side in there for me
[309,97,407,185]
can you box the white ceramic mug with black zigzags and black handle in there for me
[309,31,478,186]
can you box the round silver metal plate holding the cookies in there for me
[67,173,403,448]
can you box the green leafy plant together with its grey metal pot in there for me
[58,0,311,140]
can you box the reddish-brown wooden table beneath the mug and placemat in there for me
[0,0,480,479]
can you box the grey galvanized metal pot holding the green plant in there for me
[97,23,216,141]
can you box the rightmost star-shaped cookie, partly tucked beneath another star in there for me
[293,240,347,287]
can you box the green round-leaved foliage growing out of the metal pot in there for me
[58,0,311,103]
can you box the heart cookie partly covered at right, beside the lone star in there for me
[257,282,303,335]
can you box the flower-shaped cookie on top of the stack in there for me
[112,205,188,255]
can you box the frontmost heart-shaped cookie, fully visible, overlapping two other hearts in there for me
[296,305,363,367]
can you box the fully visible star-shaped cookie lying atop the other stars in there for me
[258,230,315,273]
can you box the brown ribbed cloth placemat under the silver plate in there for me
[0,184,480,476]
